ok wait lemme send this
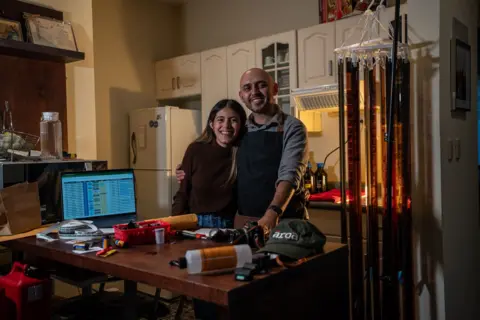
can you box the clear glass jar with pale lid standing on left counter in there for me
[40,112,63,159]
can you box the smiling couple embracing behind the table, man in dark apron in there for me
[172,68,308,230]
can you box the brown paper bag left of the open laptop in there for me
[0,182,42,236]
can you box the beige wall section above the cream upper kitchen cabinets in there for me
[182,0,319,53]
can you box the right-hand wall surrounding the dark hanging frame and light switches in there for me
[439,0,480,320]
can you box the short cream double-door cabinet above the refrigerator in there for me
[155,53,201,100]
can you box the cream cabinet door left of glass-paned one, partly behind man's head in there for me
[227,40,257,114]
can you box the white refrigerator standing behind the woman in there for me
[129,106,201,221]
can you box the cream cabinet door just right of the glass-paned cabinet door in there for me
[297,23,335,88]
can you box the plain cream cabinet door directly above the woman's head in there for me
[201,47,228,128]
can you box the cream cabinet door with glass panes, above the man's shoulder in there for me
[255,31,297,115]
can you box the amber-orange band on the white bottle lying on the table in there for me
[200,246,237,272]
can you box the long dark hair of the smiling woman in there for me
[195,99,247,183]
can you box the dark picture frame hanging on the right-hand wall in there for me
[451,38,472,111]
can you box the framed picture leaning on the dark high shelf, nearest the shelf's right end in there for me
[24,13,78,51]
